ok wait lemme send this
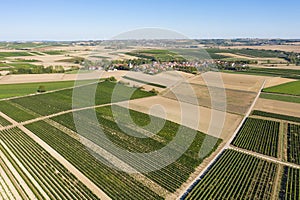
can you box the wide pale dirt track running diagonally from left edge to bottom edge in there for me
[0,112,110,199]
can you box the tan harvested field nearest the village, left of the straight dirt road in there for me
[189,72,267,92]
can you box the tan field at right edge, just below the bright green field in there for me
[254,99,300,117]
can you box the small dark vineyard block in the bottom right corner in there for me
[279,166,300,200]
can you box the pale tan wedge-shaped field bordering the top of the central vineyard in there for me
[118,96,242,140]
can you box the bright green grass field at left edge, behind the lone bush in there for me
[0,81,94,99]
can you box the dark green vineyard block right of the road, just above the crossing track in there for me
[232,118,280,157]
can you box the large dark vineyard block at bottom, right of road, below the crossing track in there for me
[183,150,277,200]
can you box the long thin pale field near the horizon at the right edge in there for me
[220,45,300,53]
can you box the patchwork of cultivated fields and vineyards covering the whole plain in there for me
[0,41,300,199]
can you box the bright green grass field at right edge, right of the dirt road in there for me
[263,81,300,96]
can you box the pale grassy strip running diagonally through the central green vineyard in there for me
[45,119,174,198]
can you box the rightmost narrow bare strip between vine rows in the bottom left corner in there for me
[0,141,50,199]
